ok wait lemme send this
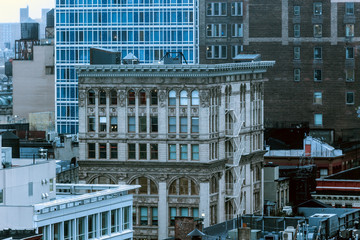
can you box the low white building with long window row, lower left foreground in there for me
[0,136,139,240]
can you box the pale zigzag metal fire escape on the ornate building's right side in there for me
[225,99,245,219]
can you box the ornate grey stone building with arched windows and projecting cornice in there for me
[77,61,275,239]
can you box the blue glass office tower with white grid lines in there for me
[55,0,199,133]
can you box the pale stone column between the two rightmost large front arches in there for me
[158,182,169,239]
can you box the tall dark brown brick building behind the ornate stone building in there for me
[199,0,360,143]
